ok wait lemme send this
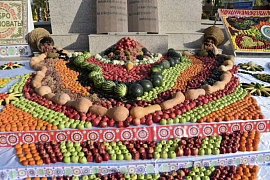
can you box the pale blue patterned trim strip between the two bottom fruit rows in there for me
[0,152,270,180]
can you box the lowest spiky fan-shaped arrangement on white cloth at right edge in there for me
[242,83,270,97]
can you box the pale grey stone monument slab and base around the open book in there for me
[50,0,203,54]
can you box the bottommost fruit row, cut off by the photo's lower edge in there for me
[24,164,260,180]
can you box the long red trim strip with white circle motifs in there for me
[0,120,270,147]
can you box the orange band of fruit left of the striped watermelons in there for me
[55,59,91,95]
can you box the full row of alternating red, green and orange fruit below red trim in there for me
[15,130,260,166]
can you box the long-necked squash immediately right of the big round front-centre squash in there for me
[130,104,161,119]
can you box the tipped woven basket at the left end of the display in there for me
[29,28,54,52]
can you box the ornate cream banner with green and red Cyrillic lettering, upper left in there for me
[0,0,28,45]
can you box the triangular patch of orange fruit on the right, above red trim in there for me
[198,93,265,123]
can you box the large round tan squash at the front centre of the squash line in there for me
[106,106,129,121]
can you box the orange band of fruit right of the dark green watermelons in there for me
[172,56,203,89]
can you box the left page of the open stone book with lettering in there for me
[97,0,128,33]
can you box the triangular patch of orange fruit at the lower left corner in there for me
[0,104,57,132]
